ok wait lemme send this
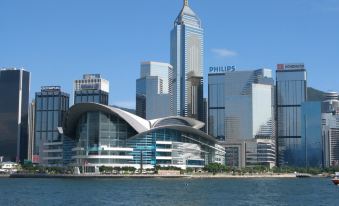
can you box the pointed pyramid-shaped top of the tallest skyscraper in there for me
[174,0,201,28]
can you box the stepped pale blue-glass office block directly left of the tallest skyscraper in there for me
[136,62,175,119]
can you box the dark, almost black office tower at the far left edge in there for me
[0,69,30,162]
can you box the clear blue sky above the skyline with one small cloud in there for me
[0,0,339,108]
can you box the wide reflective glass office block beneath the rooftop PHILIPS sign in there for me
[208,69,274,141]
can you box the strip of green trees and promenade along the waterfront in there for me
[0,163,339,178]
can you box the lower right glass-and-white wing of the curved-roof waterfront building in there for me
[128,128,224,168]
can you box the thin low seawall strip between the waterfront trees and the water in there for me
[5,174,306,179]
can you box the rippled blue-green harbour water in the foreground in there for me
[0,178,339,206]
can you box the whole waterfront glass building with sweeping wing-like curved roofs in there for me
[63,104,224,171]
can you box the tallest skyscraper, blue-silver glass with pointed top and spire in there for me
[171,0,204,120]
